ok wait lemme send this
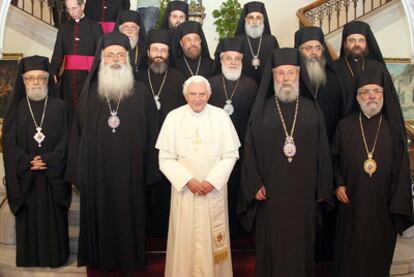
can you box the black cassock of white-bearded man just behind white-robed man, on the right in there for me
[209,75,257,236]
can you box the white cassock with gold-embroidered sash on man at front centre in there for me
[155,105,240,277]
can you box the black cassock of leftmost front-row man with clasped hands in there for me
[5,97,71,267]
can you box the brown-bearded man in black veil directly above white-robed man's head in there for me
[173,21,213,79]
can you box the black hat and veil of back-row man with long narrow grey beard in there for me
[294,26,336,71]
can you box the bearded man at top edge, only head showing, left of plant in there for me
[160,0,188,33]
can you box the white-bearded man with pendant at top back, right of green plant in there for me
[234,1,279,85]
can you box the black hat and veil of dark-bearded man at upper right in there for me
[340,20,385,65]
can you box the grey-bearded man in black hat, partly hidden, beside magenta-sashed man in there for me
[117,10,146,70]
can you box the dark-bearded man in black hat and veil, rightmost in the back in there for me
[335,21,391,115]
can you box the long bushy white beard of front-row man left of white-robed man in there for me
[98,57,135,101]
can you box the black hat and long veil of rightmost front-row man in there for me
[354,68,414,233]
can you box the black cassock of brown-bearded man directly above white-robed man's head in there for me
[174,56,213,80]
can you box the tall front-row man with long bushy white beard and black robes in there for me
[66,32,160,276]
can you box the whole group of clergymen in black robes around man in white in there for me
[3,0,414,277]
